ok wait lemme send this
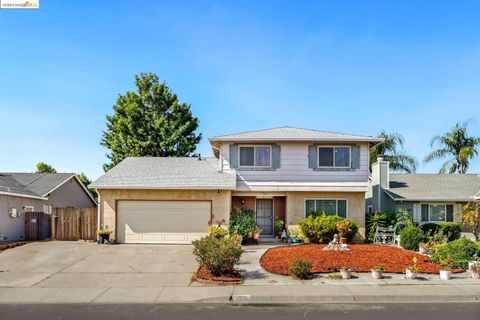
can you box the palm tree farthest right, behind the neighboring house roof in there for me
[423,121,480,174]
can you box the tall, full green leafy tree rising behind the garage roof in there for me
[101,73,202,171]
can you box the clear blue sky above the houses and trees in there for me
[0,0,480,179]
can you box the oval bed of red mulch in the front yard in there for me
[260,244,462,275]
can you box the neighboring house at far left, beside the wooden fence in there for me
[0,172,96,241]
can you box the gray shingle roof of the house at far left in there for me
[0,172,75,197]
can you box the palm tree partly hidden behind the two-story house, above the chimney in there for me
[370,130,417,173]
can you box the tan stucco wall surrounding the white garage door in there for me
[98,189,231,237]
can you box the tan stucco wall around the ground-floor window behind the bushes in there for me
[286,192,365,238]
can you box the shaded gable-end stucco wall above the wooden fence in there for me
[47,178,96,208]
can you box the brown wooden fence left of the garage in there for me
[52,208,97,241]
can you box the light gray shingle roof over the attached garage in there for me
[90,157,236,190]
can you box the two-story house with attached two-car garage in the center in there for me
[90,127,382,243]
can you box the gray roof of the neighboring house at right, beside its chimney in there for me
[385,173,480,202]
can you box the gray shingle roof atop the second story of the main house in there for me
[210,127,382,142]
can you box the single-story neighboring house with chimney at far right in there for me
[366,157,480,223]
